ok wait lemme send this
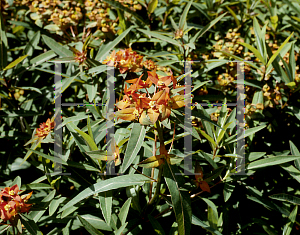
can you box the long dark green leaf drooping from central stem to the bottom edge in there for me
[163,162,192,235]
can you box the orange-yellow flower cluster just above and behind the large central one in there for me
[103,48,156,73]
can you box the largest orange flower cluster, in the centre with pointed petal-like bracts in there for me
[116,70,185,125]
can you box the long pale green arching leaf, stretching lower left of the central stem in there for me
[59,174,149,212]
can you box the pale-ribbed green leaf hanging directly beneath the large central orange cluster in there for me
[121,123,146,173]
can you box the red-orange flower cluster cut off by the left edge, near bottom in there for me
[0,185,32,222]
